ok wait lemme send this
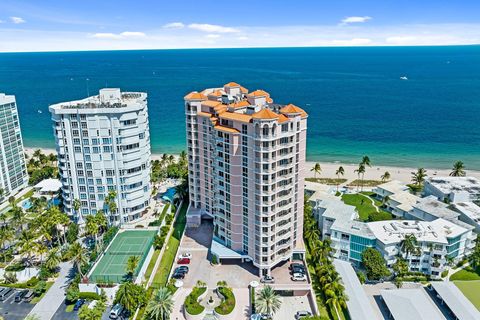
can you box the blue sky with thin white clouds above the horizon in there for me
[0,0,480,52]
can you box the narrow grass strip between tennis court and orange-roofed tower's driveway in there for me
[152,202,188,288]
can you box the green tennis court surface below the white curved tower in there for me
[90,230,156,283]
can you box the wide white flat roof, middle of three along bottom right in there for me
[380,288,445,320]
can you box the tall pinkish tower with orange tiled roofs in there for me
[185,82,307,275]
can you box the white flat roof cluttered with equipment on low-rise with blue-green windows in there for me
[367,219,467,244]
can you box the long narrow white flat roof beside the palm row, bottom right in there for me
[333,259,378,320]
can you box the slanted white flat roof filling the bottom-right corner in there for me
[431,281,480,320]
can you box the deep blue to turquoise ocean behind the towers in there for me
[0,46,480,169]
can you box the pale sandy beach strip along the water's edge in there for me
[24,147,480,183]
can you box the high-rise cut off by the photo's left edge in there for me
[0,93,28,198]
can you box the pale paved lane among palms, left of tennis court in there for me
[30,262,74,320]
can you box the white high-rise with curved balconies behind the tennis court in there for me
[50,89,150,224]
